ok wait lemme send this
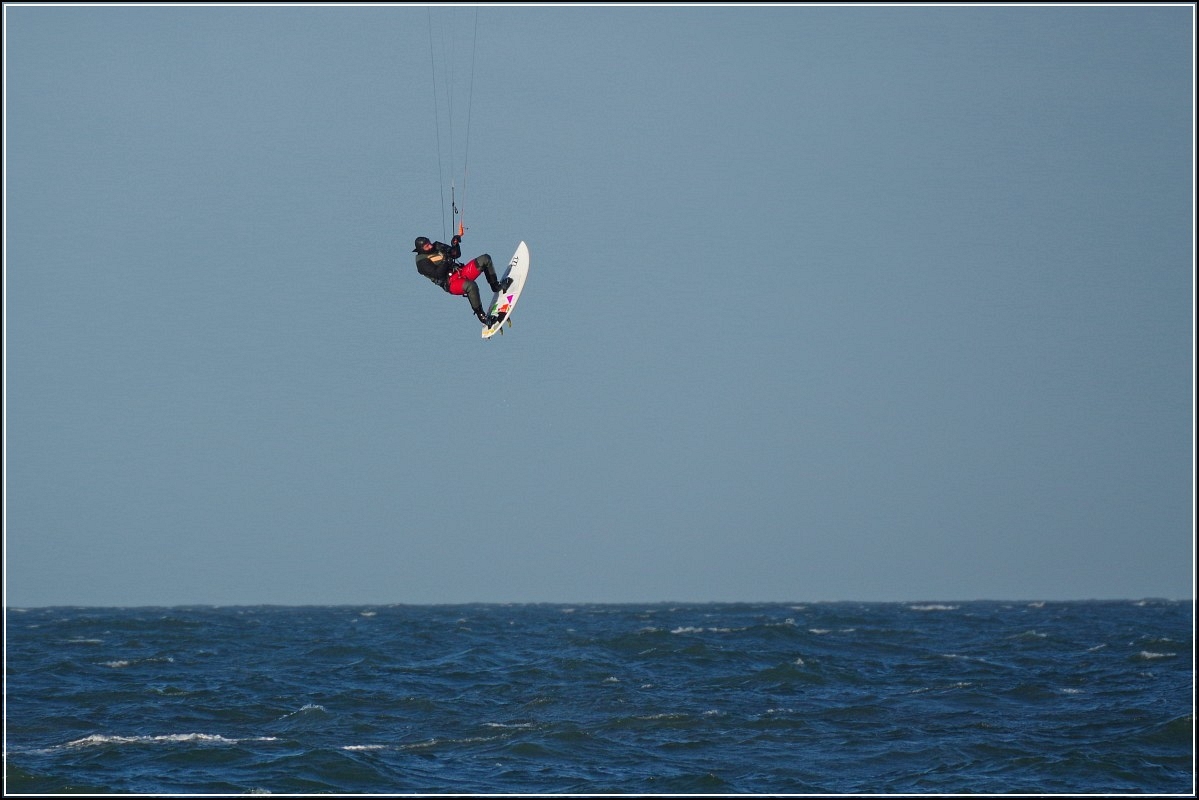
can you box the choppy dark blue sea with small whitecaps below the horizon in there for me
[5,601,1195,794]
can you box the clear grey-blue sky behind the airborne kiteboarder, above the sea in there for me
[4,4,1195,606]
